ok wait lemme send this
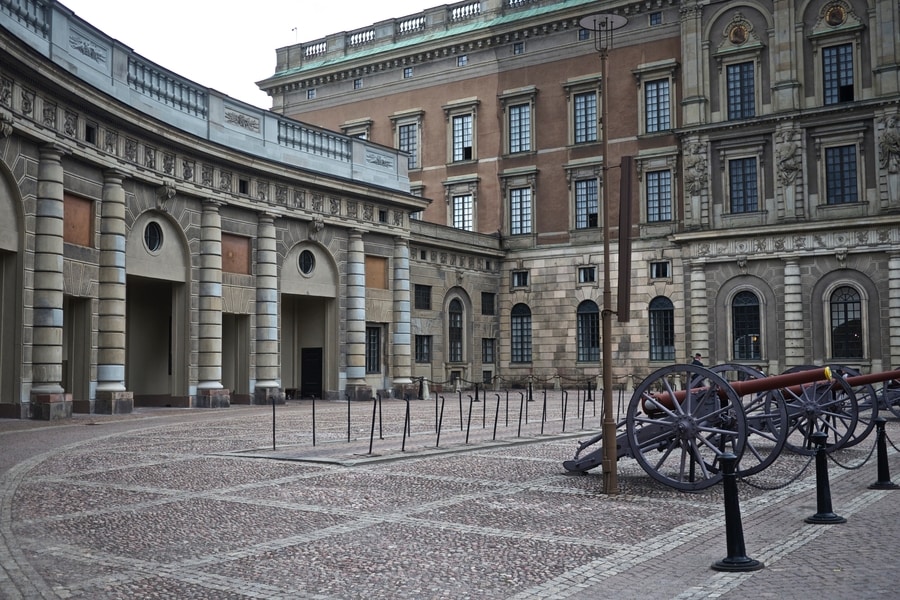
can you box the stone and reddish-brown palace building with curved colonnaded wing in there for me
[0,0,900,419]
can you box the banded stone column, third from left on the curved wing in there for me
[197,199,229,408]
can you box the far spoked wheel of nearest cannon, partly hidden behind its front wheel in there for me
[712,364,788,477]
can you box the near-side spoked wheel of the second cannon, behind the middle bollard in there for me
[782,367,859,455]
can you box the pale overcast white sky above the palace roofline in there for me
[61,0,434,108]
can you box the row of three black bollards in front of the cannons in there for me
[712,417,900,571]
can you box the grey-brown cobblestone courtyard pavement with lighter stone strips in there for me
[0,394,900,600]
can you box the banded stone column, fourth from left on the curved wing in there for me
[253,214,284,404]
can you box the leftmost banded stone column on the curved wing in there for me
[31,145,72,420]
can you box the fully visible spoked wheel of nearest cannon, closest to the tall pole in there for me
[625,364,747,491]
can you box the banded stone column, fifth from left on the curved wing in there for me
[347,229,371,400]
